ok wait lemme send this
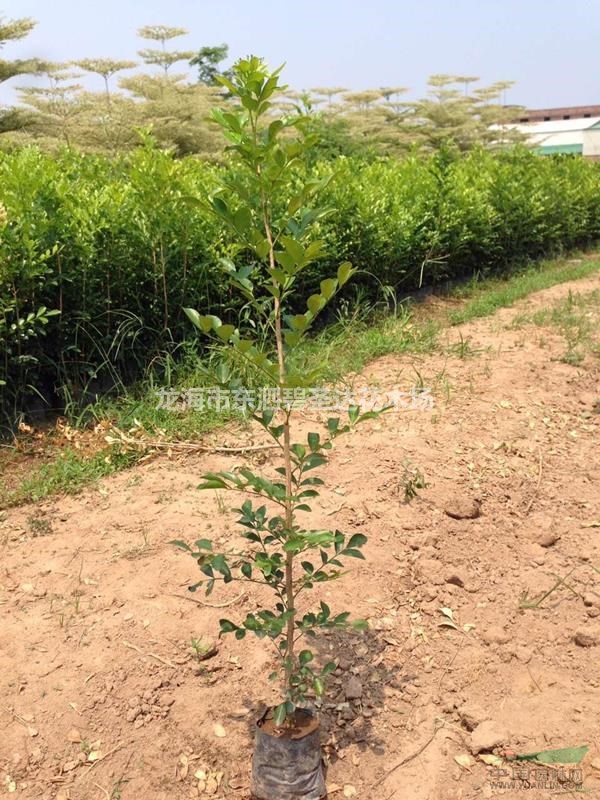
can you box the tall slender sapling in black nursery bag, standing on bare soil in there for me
[175,57,390,800]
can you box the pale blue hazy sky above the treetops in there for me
[0,0,600,107]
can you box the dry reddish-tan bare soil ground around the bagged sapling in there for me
[0,277,600,800]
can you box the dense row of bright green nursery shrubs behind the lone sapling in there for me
[0,144,600,423]
